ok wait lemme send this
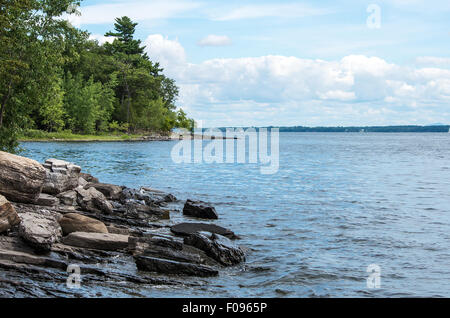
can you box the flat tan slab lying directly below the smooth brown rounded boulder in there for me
[62,232,128,251]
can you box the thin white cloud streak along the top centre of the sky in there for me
[211,3,332,21]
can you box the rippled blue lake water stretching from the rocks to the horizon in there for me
[22,133,450,297]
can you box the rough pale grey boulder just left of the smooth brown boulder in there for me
[19,210,62,252]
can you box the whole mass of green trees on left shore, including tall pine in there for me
[0,0,194,152]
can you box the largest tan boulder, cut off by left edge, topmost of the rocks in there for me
[0,151,46,203]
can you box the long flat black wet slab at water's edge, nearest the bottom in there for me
[135,256,219,277]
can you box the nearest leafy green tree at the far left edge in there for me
[0,0,79,151]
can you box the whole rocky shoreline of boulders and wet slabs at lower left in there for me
[0,152,245,297]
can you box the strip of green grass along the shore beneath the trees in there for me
[19,129,148,141]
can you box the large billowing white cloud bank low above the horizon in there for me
[146,34,450,126]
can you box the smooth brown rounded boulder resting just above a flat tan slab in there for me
[59,213,108,235]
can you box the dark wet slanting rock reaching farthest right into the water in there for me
[184,232,245,266]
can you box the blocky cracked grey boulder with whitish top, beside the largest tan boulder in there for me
[42,159,81,195]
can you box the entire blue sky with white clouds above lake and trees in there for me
[70,0,450,127]
